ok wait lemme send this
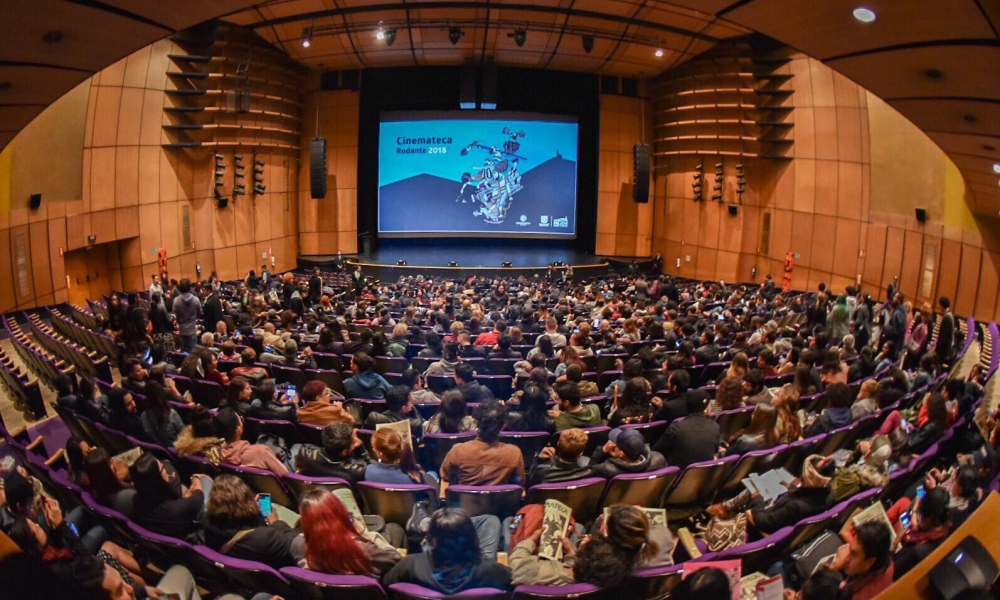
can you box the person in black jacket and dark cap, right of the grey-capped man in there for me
[653,394,720,469]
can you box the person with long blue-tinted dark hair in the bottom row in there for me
[382,506,520,595]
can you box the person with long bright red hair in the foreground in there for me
[292,489,400,577]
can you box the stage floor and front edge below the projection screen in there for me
[298,238,649,281]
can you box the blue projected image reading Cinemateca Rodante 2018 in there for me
[378,114,577,237]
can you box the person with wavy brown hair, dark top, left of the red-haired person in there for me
[205,475,299,569]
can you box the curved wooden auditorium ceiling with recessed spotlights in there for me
[0,0,1000,217]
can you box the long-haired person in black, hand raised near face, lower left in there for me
[129,452,211,542]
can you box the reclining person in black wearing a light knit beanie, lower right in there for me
[708,455,834,535]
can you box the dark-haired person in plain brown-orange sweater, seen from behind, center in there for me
[440,400,524,498]
